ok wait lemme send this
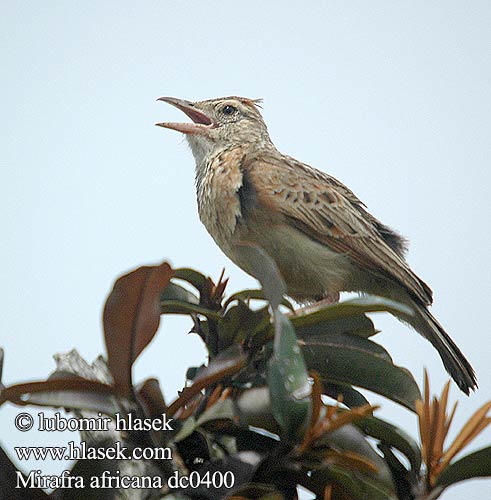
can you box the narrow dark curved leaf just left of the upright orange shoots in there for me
[354,417,421,472]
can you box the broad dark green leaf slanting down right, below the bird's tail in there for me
[300,334,421,411]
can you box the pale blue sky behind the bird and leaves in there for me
[0,0,491,500]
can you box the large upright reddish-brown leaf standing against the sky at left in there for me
[103,263,174,396]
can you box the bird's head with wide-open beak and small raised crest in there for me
[156,97,271,163]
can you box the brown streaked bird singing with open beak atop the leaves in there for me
[156,96,477,395]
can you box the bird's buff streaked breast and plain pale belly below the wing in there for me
[197,148,352,300]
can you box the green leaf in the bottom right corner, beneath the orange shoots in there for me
[436,446,491,488]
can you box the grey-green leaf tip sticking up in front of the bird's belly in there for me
[238,244,286,309]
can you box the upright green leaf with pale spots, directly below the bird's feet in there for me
[268,311,311,439]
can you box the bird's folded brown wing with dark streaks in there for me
[242,155,432,305]
